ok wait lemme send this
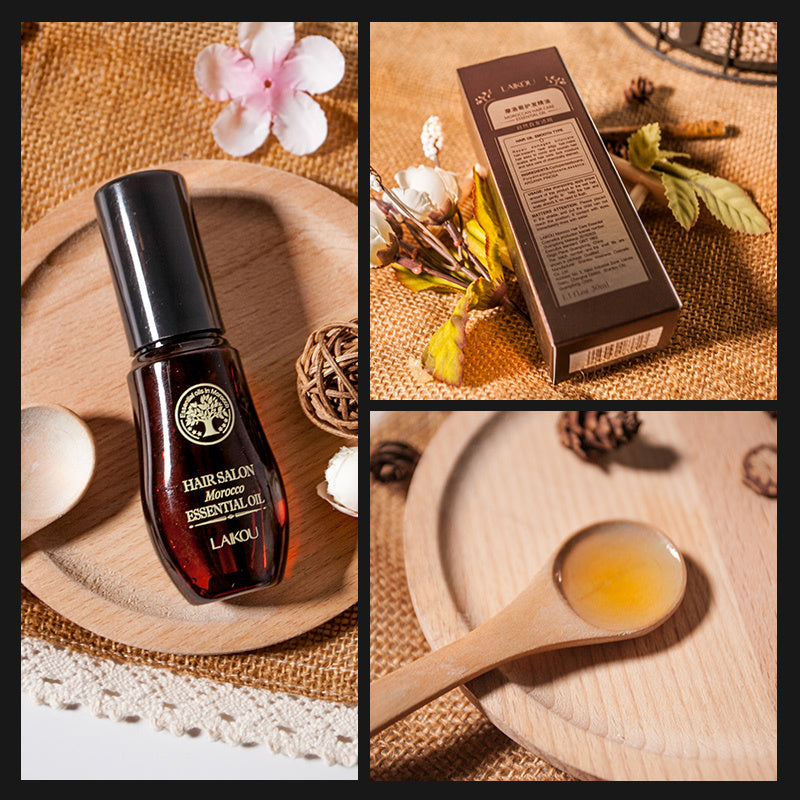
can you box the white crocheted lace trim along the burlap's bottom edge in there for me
[21,637,358,767]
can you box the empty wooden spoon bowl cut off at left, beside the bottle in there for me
[20,405,95,539]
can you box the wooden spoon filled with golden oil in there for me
[369,520,686,736]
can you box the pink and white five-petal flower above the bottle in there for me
[194,22,345,156]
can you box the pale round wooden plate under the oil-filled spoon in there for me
[404,411,777,780]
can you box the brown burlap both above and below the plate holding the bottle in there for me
[20,22,358,704]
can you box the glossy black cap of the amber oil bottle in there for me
[94,170,223,353]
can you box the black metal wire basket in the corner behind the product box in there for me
[619,22,778,85]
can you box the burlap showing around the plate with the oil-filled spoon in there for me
[369,411,572,781]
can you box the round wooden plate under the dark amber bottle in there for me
[21,161,358,654]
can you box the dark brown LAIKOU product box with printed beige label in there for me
[458,47,681,383]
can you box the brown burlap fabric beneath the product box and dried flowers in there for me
[370,22,777,400]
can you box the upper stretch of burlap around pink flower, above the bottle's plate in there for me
[20,22,358,230]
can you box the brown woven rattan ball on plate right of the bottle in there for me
[296,320,358,438]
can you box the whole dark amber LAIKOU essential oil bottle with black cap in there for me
[95,170,288,603]
